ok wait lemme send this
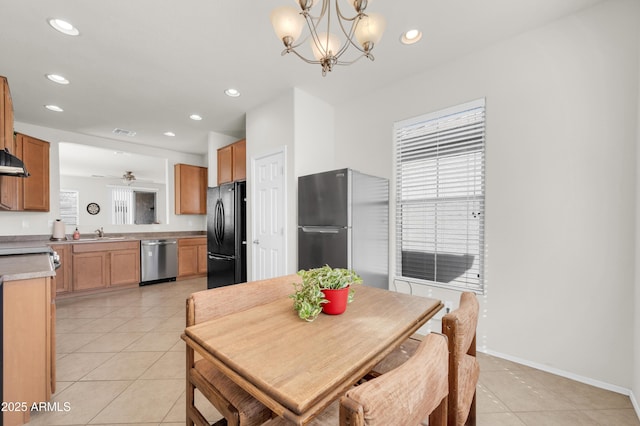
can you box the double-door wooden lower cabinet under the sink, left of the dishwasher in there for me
[71,241,140,292]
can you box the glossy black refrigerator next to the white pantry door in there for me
[207,182,247,288]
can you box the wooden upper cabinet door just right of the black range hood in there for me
[16,133,49,212]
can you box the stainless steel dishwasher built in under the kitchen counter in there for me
[140,238,178,285]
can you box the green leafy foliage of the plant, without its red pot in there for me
[289,265,362,321]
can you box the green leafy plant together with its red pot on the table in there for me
[290,265,362,321]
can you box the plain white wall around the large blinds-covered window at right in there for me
[336,0,640,391]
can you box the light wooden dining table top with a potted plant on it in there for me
[183,286,443,425]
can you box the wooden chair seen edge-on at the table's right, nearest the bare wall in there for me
[442,292,480,426]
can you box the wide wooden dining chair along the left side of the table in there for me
[186,274,300,426]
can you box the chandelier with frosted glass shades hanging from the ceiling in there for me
[271,0,386,76]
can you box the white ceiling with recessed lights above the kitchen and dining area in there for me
[0,0,599,154]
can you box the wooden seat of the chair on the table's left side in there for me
[194,359,271,424]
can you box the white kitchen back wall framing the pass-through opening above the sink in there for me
[0,122,207,235]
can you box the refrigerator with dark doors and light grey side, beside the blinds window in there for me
[298,169,389,289]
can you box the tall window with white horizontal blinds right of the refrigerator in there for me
[394,99,485,293]
